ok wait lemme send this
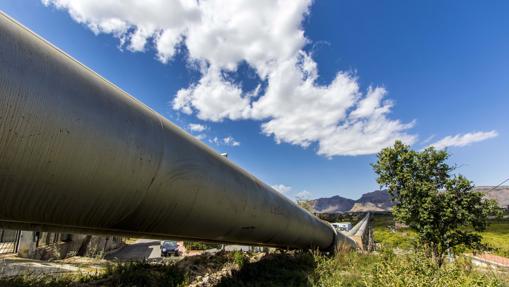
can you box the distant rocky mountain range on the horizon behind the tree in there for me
[309,186,509,213]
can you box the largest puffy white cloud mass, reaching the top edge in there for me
[42,0,416,157]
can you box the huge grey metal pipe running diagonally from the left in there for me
[0,13,335,249]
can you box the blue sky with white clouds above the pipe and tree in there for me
[0,0,509,199]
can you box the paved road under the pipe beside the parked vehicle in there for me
[105,239,161,260]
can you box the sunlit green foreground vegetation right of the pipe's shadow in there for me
[312,251,509,286]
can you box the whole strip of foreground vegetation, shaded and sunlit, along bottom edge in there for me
[0,251,509,287]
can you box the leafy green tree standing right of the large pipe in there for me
[373,141,499,266]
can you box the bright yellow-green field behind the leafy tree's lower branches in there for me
[373,214,509,257]
